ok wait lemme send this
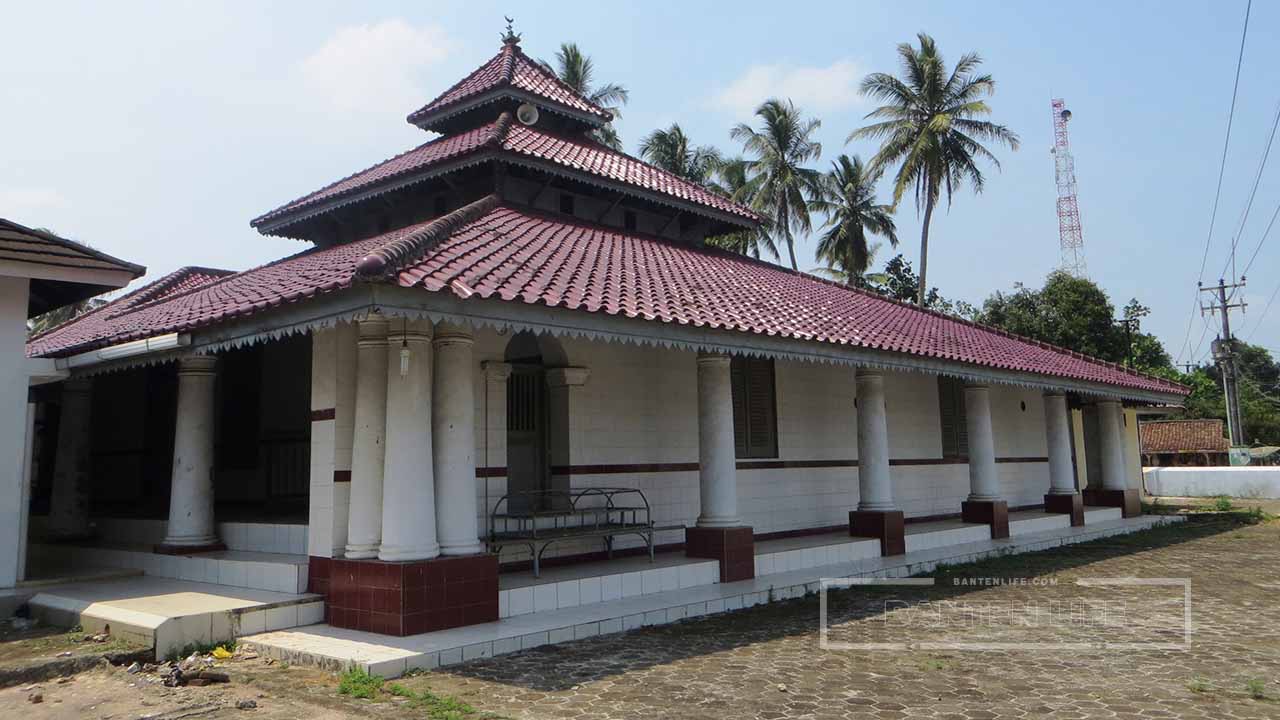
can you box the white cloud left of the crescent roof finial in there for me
[300,19,452,114]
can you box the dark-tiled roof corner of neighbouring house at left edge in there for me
[0,218,147,316]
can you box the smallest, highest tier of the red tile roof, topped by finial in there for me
[408,44,613,129]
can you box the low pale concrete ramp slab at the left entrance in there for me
[28,577,324,660]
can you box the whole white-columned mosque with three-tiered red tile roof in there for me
[17,30,1187,645]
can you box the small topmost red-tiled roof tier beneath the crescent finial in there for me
[407,36,613,131]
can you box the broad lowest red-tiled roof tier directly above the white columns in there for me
[28,196,1187,395]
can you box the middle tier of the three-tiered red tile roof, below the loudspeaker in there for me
[252,113,759,225]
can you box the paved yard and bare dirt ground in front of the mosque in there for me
[0,501,1280,720]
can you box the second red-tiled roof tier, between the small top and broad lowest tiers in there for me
[251,113,759,232]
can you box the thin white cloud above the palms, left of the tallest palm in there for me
[712,59,863,118]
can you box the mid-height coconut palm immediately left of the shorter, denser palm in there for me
[730,99,822,270]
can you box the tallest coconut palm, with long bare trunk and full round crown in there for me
[846,32,1018,305]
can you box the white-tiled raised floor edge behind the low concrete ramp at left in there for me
[31,543,307,593]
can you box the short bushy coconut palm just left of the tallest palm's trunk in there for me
[809,155,897,284]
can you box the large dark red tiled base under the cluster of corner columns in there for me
[322,553,498,635]
